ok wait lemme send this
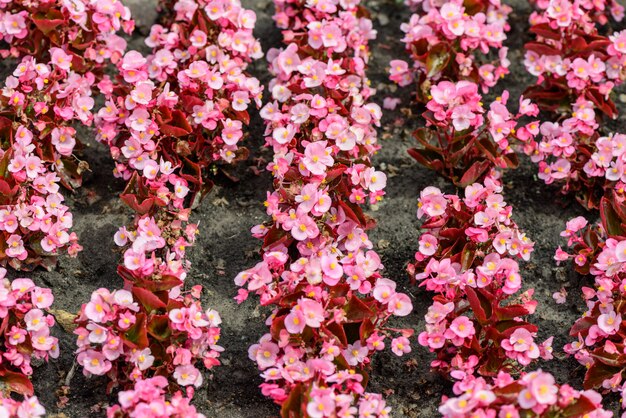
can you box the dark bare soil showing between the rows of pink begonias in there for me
[0,0,626,418]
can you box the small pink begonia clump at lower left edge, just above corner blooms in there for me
[0,267,59,398]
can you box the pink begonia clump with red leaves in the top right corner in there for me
[524,0,626,208]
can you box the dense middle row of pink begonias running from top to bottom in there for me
[235,0,412,417]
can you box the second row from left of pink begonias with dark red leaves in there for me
[76,0,262,404]
